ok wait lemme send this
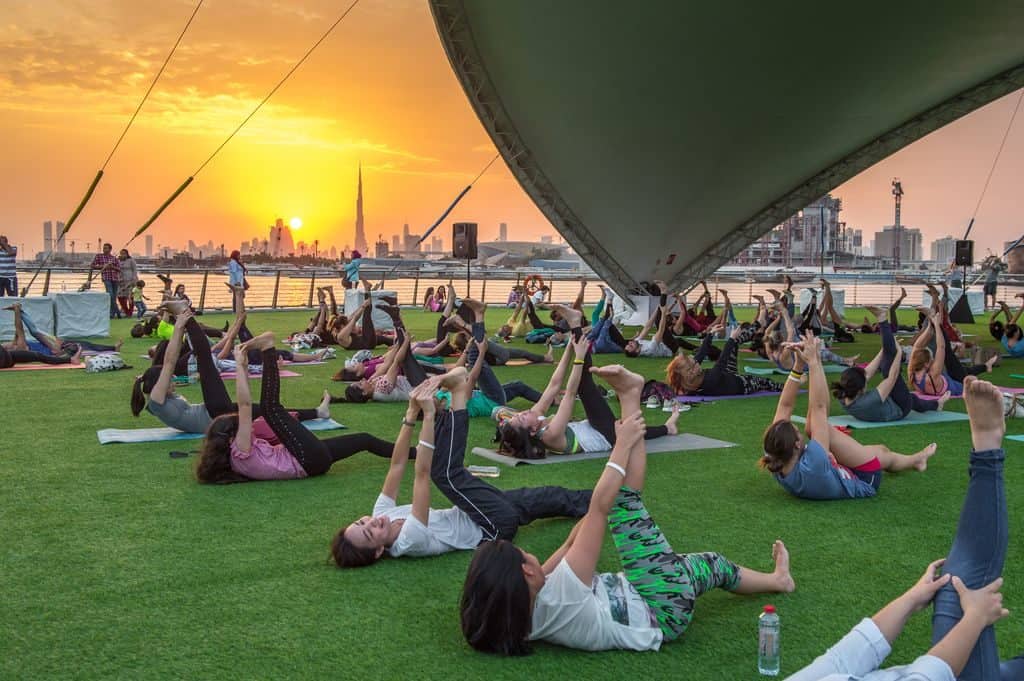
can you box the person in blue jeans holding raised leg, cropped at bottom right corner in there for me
[790,376,1024,681]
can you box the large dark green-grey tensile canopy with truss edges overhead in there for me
[430,0,1024,293]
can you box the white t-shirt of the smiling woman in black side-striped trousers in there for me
[373,495,483,558]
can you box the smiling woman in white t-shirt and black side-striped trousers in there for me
[331,367,591,567]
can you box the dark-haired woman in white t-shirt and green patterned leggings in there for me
[460,366,795,655]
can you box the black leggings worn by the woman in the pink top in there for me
[260,348,416,477]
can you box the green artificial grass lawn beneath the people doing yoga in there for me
[0,309,1024,681]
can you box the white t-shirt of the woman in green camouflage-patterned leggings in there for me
[529,558,662,650]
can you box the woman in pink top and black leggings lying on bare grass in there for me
[196,333,415,482]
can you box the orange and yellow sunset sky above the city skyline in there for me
[0,0,1024,257]
